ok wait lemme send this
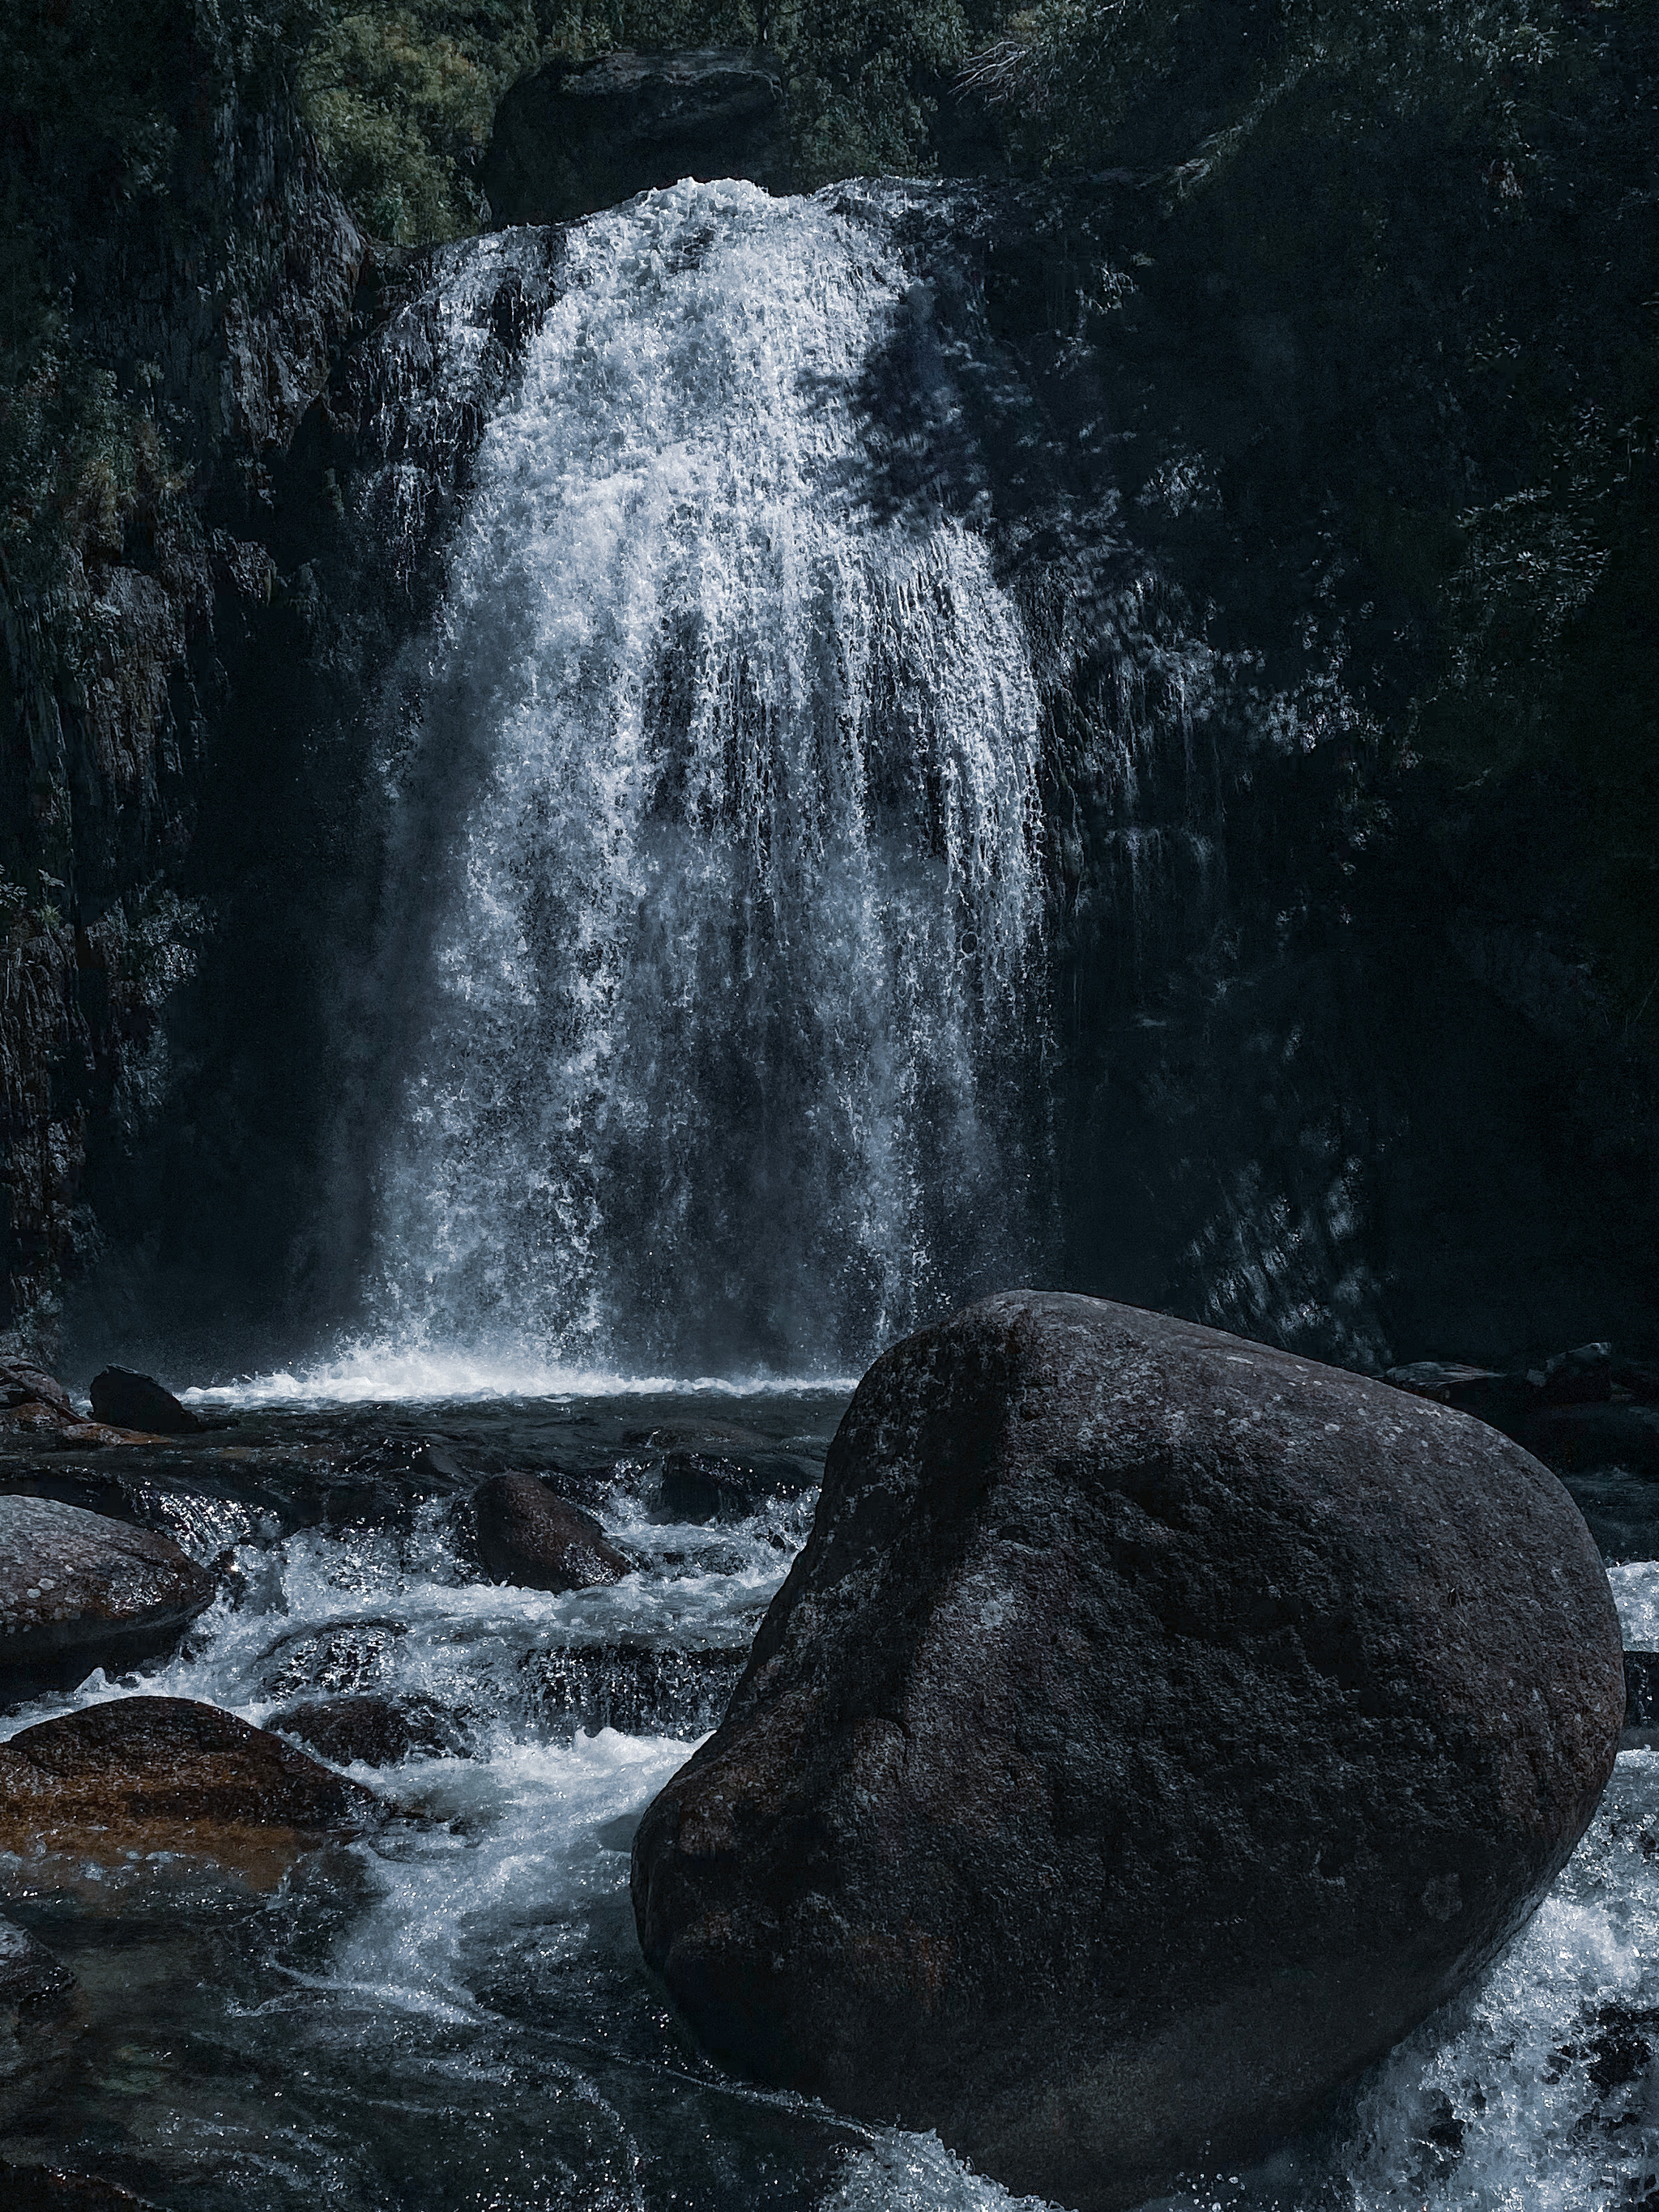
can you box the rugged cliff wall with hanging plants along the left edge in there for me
[0,4,363,1328]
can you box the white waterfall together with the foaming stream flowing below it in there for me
[0,185,1659,2212]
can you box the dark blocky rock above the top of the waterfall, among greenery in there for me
[482,46,790,224]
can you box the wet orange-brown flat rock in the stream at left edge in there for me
[0,1697,382,1878]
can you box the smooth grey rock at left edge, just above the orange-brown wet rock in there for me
[0,1498,219,1697]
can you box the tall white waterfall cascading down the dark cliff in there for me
[369,184,1044,1374]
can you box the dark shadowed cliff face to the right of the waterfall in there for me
[871,15,1659,1365]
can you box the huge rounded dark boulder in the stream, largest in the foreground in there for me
[633,1292,1623,2212]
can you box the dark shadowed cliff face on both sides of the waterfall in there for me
[13,13,1659,1365]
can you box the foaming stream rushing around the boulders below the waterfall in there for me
[0,1389,1659,2212]
